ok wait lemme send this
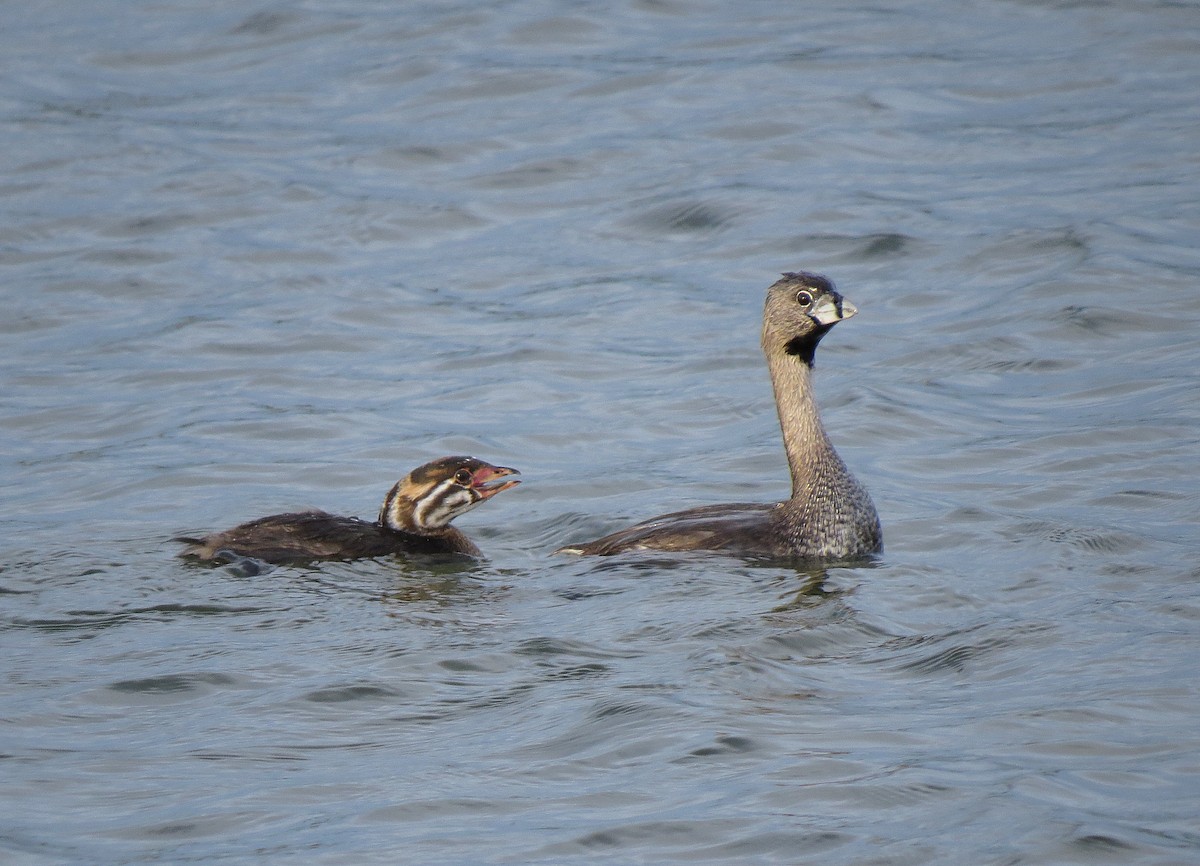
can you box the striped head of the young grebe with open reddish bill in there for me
[379,457,521,535]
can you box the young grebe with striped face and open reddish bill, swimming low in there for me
[179,457,521,564]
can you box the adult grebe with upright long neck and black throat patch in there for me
[559,272,883,560]
